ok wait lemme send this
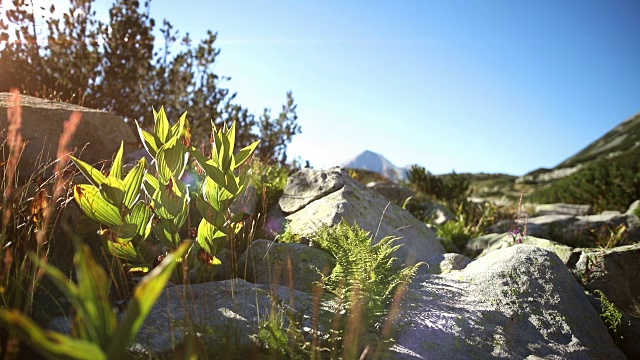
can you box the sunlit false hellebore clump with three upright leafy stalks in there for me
[72,108,259,280]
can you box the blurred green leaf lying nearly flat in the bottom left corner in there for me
[0,309,107,360]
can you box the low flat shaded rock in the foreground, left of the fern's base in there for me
[135,279,331,356]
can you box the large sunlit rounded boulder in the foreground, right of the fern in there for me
[392,245,625,359]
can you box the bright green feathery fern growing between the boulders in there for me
[312,220,423,358]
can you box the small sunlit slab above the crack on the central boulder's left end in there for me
[279,168,342,213]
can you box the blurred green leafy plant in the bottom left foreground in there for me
[0,232,191,359]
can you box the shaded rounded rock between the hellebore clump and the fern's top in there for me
[238,240,336,293]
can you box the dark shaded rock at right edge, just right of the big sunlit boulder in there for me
[567,243,640,311]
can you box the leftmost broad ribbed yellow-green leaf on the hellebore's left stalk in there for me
[73,184,122,226]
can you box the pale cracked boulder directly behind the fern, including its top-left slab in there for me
[279,168,445,263]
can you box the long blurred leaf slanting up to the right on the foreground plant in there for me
[107,241,192,359]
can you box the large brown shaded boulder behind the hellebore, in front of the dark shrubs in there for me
[0,93,139,178]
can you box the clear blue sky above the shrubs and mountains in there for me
[23,0,640,175]
